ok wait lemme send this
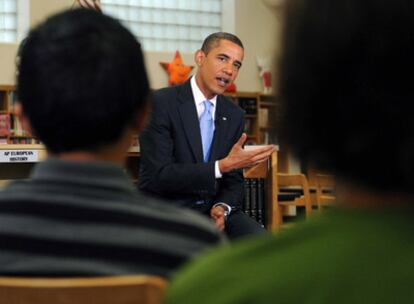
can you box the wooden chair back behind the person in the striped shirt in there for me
[0,275,167,304]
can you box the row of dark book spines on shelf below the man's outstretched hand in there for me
[242,178,266,226]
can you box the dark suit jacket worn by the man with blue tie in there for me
[139,81,244,212]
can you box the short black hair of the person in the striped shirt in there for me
[17,9,149,153]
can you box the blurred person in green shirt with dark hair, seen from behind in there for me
[166,0,414,304]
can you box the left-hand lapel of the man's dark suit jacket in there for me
[178,80,203,162]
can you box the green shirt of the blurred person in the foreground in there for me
[166,206,414,304]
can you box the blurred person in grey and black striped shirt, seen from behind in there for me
[0,9,222,276]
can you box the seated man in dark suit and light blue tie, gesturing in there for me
[139,32,274,238]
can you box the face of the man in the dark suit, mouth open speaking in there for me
[195,39,244,99]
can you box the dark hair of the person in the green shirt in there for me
[279,0,414,193]
